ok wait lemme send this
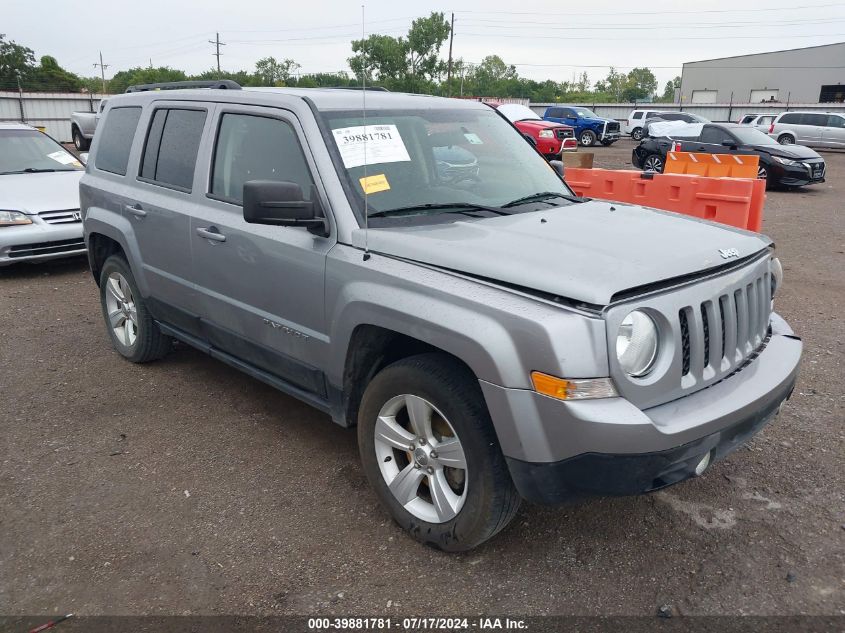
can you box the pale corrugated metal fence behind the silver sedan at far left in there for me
[0,92,103,142]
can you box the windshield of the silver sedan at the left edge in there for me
[0,130,82,175]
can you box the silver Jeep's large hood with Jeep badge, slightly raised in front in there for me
[353,200,771,305]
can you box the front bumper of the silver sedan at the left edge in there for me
[0,216,86,266]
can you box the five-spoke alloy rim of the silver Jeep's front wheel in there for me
[374,394,468,523]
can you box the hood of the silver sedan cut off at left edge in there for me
[0,170,85,214]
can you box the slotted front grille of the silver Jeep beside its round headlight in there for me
[678,272,772,388]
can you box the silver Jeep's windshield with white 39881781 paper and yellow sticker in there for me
[323,107,573,220]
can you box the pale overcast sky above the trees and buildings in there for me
[0,0,845,91]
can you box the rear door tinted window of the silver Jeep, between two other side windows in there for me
[141,108,205,191]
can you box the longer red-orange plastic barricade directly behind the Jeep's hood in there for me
[565,169,766,232]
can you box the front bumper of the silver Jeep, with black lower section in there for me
[481,314,802,503]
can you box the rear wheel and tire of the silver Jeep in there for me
[100,255,173,363]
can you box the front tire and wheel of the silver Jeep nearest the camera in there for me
[358,354,520,552]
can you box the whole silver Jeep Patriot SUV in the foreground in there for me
[81,82,801,551]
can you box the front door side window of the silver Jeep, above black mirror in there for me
[211,114,314,204]
